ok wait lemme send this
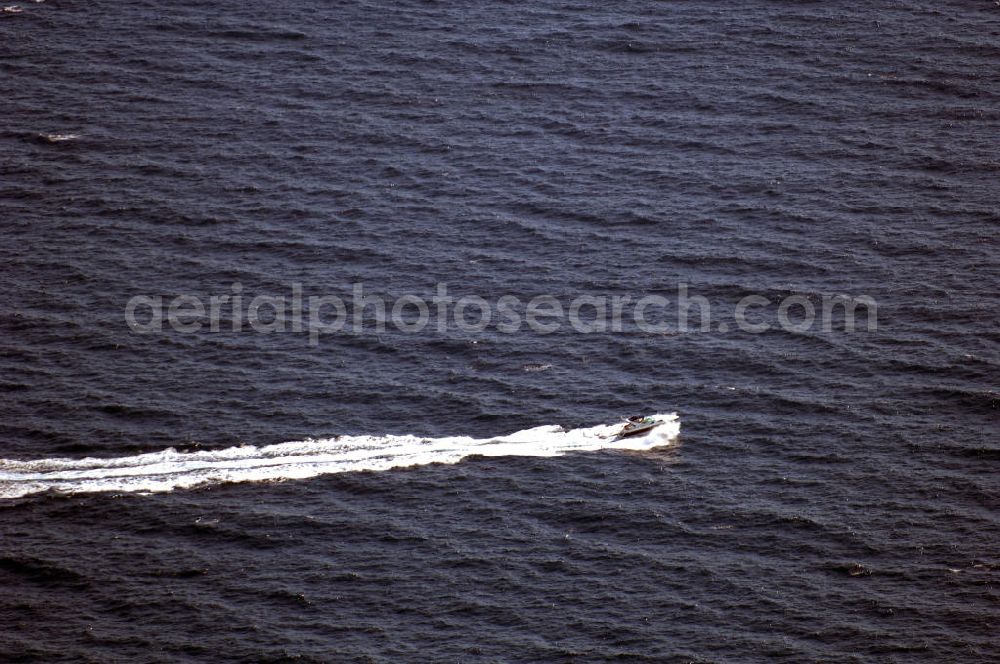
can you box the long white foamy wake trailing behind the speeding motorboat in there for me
[0,413,680,498]
